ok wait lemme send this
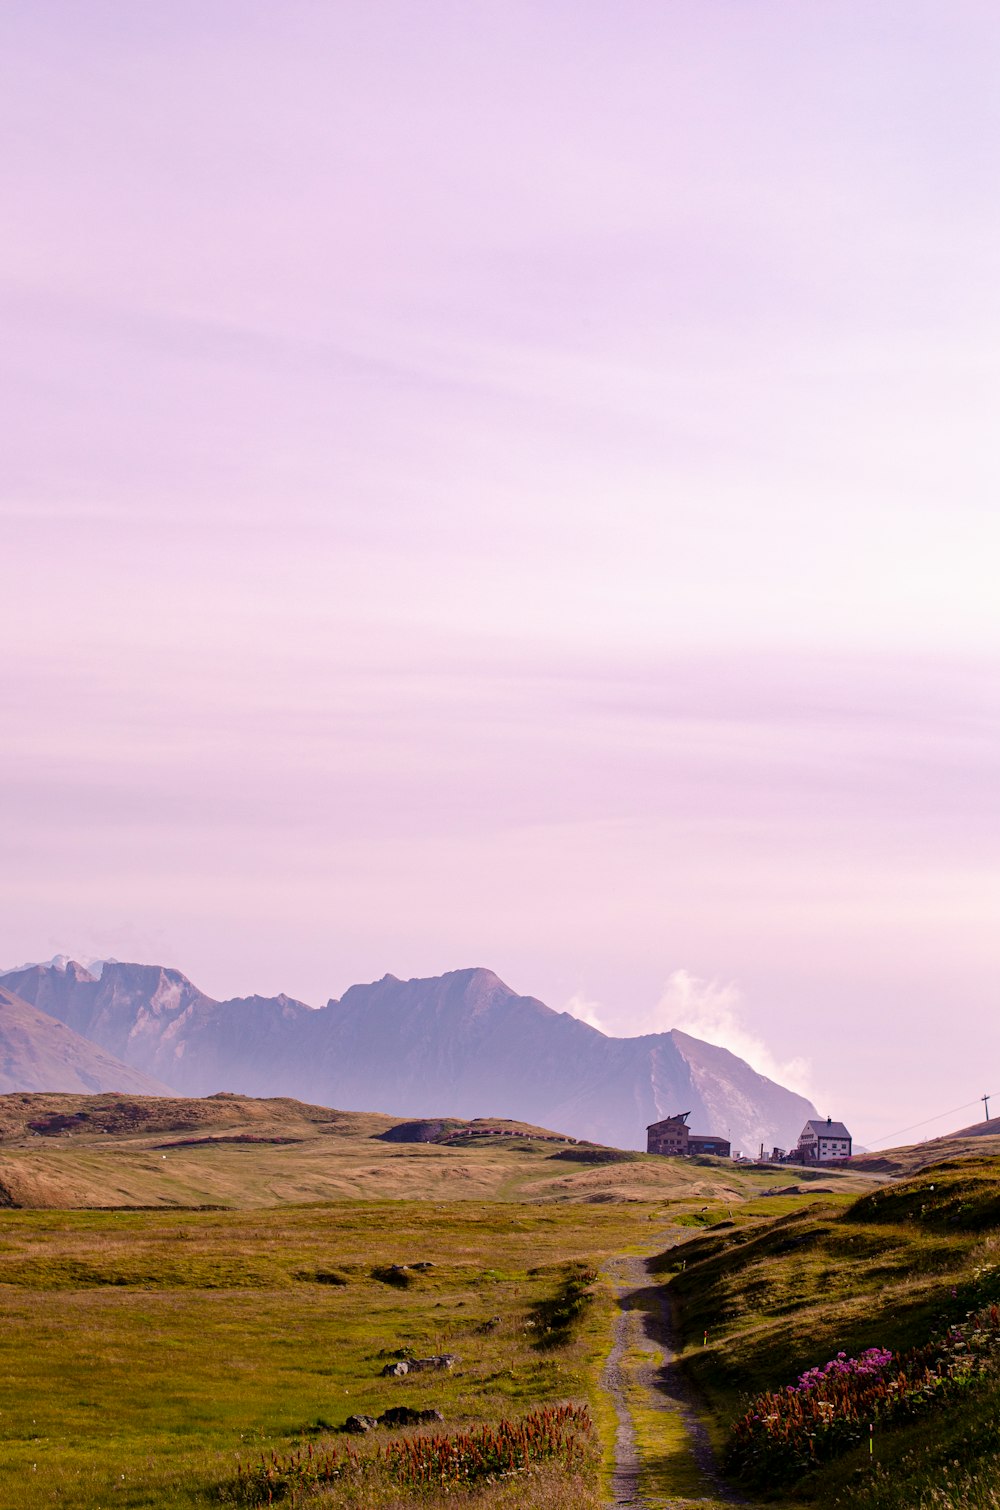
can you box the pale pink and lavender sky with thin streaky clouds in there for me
[0,0,1000,1145]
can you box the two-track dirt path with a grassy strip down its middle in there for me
[601,1255,746,1510]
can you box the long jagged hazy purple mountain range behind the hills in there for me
[0,962,816,1152]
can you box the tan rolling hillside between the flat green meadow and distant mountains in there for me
[0,1095,872,1220]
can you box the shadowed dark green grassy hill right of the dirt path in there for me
[654,1157,1000,1510]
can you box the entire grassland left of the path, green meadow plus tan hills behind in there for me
[0,1096,873,1510]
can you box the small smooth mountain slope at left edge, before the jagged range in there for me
[0,986,169,1096]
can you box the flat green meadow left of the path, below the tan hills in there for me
[0,1202,647,1507]
